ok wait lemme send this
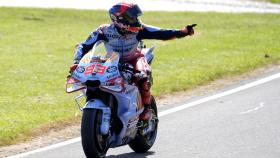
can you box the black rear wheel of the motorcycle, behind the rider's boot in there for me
[129,97,158,153]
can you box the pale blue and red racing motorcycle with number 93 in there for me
[66,43,158,158]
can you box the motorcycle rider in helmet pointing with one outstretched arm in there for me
[70,2,194,120]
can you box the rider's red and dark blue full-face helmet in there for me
[109,2,143,33]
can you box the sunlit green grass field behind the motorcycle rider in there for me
[0,8,280,146]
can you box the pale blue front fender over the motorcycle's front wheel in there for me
[83,99,111,135]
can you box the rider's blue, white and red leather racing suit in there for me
[74,23,186,106]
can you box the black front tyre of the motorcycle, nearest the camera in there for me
[81,109,108,158]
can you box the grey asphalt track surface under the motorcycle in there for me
[8,72,280,158]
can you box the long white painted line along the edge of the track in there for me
[8,73,280,158]
